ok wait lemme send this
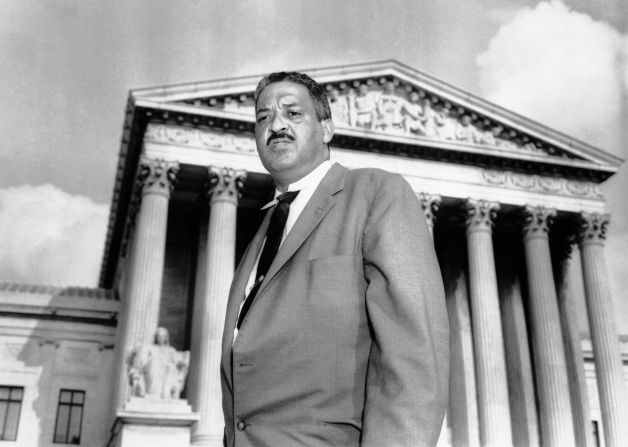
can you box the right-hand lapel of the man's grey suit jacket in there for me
[257,163,347,297]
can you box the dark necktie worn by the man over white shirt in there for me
[236,191,299,329]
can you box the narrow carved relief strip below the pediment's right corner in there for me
[482,169,603,199]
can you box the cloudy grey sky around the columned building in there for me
[0,0,628,334]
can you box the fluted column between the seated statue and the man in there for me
[189,167,246,446]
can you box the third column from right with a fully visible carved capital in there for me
[466,199,512,447]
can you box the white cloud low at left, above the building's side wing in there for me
[0,184,108,287]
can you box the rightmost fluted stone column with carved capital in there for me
[579,213,628,447]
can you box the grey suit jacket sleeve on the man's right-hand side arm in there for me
[361,175,449,447]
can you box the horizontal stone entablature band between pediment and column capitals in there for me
[143,124,605,213]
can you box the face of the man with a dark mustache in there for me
[255,81,333,188]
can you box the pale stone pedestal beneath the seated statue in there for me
[107,396,199,447]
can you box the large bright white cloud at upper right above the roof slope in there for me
[476,1,623,154]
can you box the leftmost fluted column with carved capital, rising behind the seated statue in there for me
[114,159,179,408]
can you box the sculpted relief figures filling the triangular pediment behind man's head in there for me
[194,78,564,156]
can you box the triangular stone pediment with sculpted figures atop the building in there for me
[132,61,622,178]
